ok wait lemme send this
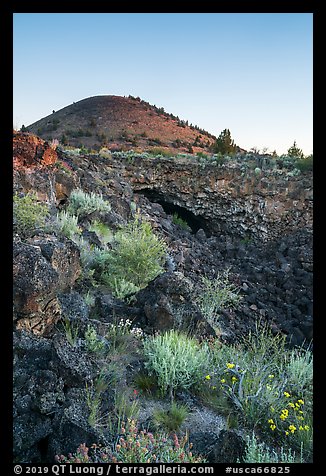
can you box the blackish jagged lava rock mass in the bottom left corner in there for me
[13,331,101,463]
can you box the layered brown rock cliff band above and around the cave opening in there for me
[124,158,313,242]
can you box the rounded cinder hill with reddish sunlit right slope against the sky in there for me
[27,96,216,152]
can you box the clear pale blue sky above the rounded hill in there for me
[13,13,313,154]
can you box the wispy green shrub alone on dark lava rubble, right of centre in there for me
[195,270,242,327]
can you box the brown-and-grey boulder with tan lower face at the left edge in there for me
[13,236,81,333]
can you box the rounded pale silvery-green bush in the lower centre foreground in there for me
[144,330,208,400]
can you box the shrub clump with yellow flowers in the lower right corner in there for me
[209,324,312,459]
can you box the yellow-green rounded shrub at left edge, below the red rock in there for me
[13,192,49,235]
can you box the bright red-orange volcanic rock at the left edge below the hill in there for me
[13,131,58,168]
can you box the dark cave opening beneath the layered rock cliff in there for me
[135,189,212,236]
